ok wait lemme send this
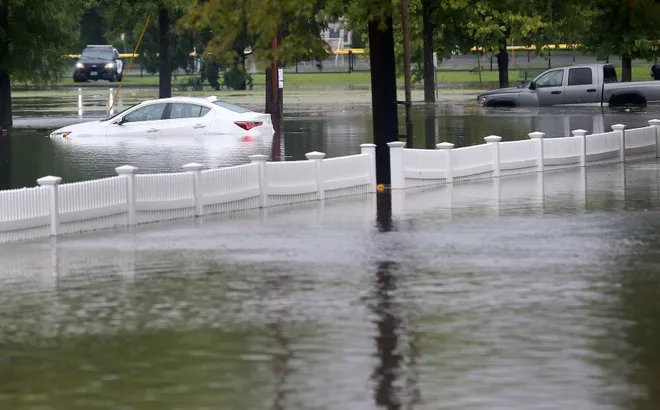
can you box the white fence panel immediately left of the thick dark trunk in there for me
[323,154,371,197]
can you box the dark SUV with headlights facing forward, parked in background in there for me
[73,45,124,83]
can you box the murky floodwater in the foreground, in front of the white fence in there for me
[0,162,660,410]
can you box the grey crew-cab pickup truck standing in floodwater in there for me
[477,64,660,107]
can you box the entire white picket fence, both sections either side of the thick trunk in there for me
[0,120,660,242]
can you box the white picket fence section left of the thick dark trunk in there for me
[0,149,376,242]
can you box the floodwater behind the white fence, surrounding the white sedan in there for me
[0,89,660,189]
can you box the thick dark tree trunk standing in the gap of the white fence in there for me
[368,15,399,185]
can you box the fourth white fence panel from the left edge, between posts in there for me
[202,164,259,213]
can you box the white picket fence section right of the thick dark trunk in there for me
[388,120,660,189]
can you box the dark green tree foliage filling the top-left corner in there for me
[0,0,86,83]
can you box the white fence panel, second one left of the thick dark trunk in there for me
[266,161,316,205]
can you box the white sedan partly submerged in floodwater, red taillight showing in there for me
[50,97,274,140]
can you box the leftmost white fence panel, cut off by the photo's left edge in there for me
[0,187,50,232]
